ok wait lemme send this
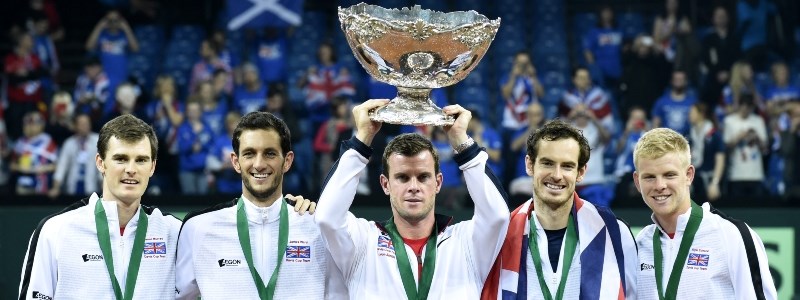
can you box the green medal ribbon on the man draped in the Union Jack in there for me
[528,213,578,300]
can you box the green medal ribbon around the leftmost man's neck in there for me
[94,199,147,300]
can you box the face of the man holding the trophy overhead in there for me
[380,151,443,222]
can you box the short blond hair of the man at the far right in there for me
[633,128,692,166]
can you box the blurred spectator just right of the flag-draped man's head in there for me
[567,104,614,207]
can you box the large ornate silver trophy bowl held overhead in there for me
[339,3,500,126]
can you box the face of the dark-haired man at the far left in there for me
[95,136,156,203]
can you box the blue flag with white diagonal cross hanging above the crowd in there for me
[226,0,303,30]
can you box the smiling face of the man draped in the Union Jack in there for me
[525,138,586,208]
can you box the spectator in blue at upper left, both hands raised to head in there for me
[86,10,139,89]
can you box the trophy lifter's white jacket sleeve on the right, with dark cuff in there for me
[454,144,511,282]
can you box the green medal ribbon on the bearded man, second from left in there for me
[236,198,289,300]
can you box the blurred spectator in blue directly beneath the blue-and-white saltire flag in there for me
[251,27,289,85]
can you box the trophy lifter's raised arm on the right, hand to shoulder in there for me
[443,105,510,281]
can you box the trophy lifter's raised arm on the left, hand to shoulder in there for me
[314,100,388,278]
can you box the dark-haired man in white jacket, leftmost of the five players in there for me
[19,115,181,299]
